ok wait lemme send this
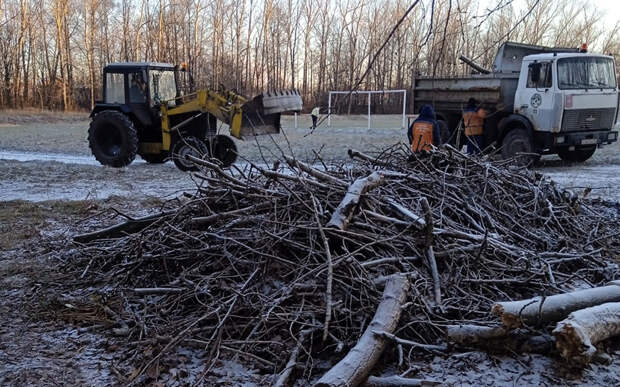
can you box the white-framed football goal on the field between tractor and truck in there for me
[325,90,407,129]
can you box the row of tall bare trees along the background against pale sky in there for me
[0,0,620,110]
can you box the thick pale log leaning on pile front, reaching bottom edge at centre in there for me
[315,275,409,387]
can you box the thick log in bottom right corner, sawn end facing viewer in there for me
[553,302,620,365]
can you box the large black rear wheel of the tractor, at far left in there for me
[88,110,138,168]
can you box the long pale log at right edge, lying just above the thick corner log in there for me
[491,283,620,328]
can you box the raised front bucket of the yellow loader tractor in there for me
[239,90,303,137]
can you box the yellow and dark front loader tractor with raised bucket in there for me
[88,62,302,171]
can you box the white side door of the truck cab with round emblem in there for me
[515,61,555,132]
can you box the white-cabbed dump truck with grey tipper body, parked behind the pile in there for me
[413,42,620,162]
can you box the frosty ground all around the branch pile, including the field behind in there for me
[0,110,620,386]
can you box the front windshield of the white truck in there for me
[558,57,616,89]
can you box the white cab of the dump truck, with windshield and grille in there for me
[514,53,619,161]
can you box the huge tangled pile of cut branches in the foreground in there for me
[52,147,620,385]
